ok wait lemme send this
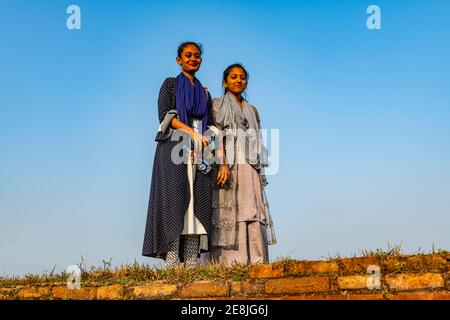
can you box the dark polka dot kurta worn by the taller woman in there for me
[142,77,214,259]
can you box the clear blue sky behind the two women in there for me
[0,0,450,276]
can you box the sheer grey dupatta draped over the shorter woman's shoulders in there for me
[212,93,277,249]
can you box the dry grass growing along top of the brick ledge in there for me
[0,244,449,288]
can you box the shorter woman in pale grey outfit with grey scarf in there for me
[211,64,276,265]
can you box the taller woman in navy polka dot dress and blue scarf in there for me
[142,42,214,267]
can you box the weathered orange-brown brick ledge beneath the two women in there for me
[0,253,450,300]
